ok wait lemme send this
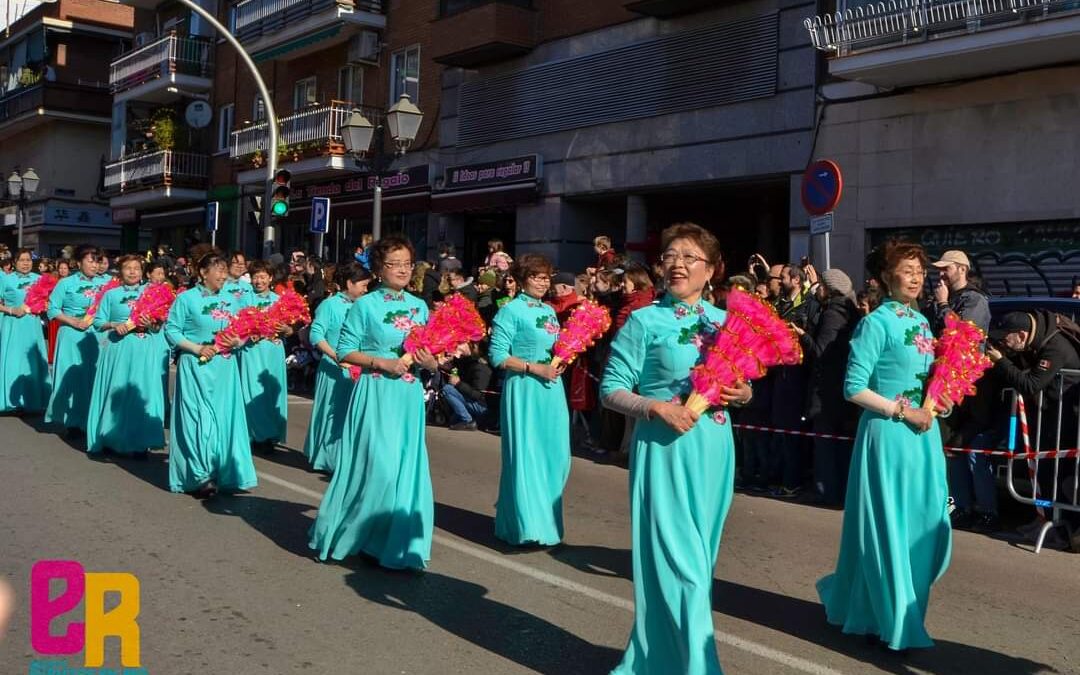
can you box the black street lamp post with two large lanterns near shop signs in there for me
[341,94,423,241]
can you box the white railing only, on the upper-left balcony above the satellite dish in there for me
[109,35,214,93]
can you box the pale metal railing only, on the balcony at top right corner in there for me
[805,0,1080,56]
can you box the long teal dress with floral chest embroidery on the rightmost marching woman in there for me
[818,301,953,649]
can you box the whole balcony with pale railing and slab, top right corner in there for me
[806,0,1080,87]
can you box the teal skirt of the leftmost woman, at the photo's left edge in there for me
[0,314,53,413]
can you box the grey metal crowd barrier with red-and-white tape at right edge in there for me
[1005,369,1080,553]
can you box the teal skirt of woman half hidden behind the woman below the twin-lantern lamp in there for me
[303,356,355,473]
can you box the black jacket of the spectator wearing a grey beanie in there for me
[799,297,860,420]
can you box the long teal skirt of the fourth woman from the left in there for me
[168,353,258,492]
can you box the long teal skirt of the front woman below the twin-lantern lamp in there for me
[309,373,434,569]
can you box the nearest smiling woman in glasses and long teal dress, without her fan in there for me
[600,224,751,675]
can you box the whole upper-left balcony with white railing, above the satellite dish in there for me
[109,35,214,103]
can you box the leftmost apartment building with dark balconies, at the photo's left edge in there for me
[0,0,133,255]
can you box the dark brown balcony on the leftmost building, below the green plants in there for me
[0,82,112,140]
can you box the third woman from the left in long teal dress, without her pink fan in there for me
[86,255,168,457]
